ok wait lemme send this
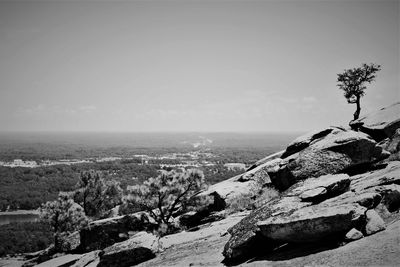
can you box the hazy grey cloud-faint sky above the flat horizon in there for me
[0,0,400,131]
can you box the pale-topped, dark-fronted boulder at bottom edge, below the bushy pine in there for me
[98,232,158,267]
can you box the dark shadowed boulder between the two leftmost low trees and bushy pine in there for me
[80,212,155,251]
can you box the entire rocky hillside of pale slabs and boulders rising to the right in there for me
[3,103,400,266]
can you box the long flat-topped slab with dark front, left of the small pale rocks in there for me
[257,204,366,243]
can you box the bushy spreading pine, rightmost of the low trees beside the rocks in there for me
[126,169,206,234]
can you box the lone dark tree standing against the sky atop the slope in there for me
[337,63,381,120]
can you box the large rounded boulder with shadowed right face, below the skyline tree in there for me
[270,128,382,190]
